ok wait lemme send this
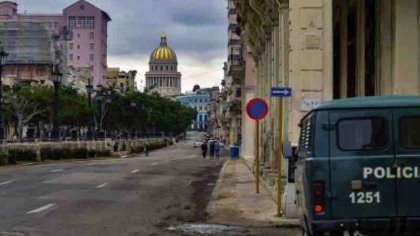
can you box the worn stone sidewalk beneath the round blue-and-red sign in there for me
[207,159,298,227]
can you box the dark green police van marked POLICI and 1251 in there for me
[295,97,420,235]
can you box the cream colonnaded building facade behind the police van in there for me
[231,0,420,218]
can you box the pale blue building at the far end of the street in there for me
[176,90,211,130]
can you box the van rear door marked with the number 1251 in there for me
[329,109,396,219]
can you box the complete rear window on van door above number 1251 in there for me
[337,118,389,151]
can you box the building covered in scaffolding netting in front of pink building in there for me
[0,22,55,85]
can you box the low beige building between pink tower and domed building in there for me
[106,68,137,92]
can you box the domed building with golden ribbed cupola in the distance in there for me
[146,33,181,97]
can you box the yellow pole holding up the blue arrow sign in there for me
[277,98,284,217]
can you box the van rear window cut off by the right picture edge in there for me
[400,117,420,148]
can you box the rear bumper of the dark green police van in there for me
[310,217,420,235]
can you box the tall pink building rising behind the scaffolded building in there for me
[0,0,111,85]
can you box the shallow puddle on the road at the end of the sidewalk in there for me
[167,224,288,236]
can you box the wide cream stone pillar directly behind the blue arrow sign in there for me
[288,0,333,145]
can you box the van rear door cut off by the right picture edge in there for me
[394,108,420,217]
